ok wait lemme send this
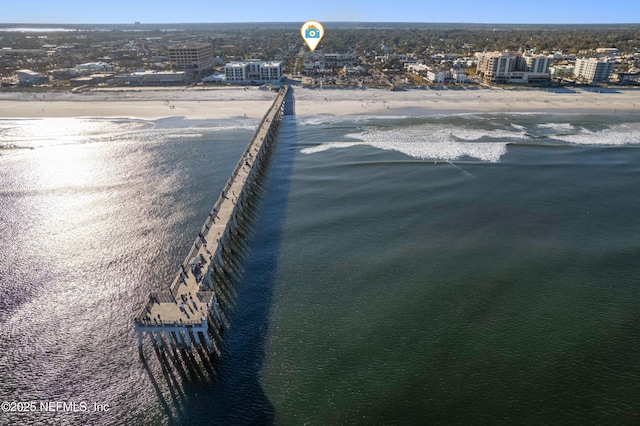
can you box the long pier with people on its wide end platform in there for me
[134,86,289,350]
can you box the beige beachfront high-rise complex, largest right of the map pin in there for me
[476,52,551,83]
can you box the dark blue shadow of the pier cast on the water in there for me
[144,88,296,425]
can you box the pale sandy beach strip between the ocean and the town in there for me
[0,87,640,120]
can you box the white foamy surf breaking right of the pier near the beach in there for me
[301,115,640,162]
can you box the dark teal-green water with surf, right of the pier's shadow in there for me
[262,111,640,424]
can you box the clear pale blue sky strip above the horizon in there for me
[0,0,640,24]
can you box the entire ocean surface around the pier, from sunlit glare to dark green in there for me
[0,112,640,425]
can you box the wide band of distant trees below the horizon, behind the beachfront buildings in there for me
[0,23,640,78]
